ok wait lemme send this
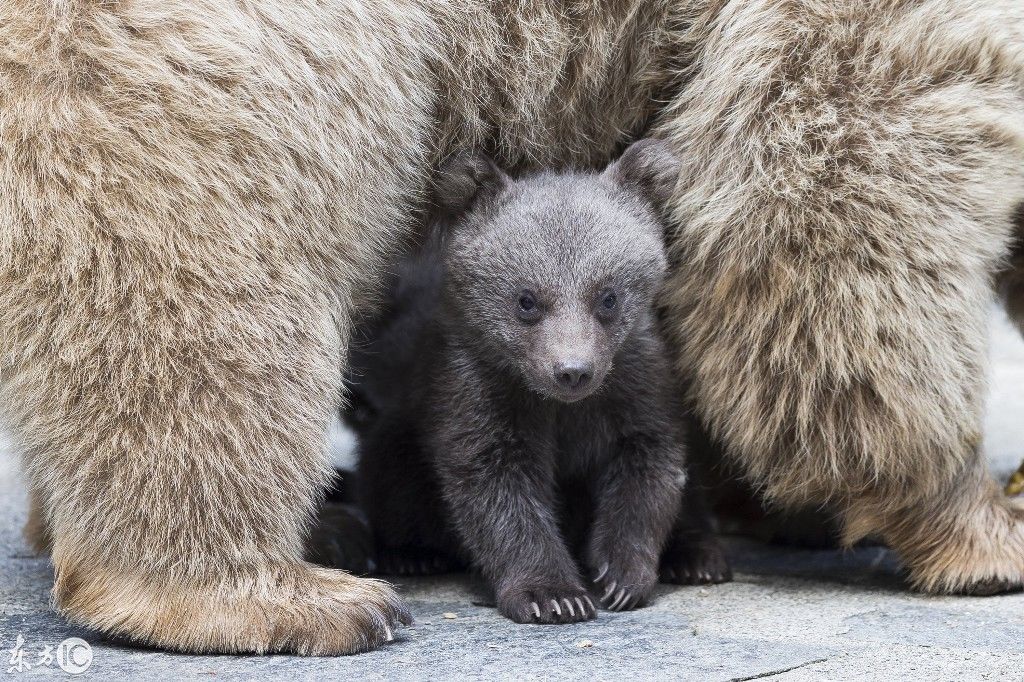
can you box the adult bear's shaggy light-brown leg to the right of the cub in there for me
[656,2,1024,592]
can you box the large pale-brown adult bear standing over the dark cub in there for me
[0,0,1024,653]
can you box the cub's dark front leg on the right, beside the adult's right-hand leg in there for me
[586,434,685,611]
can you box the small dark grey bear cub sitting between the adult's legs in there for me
[339,139,730,623]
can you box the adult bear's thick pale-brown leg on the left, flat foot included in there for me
[0,0,434,654]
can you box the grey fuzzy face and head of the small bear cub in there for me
[442,141,678,402]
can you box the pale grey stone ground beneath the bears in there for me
[0,315,1024,682]
